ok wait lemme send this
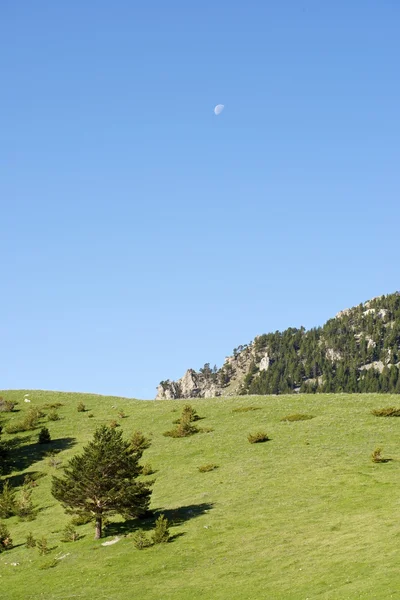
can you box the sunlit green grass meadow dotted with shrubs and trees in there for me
[0,390,400,600]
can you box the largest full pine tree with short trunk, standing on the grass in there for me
[52,426,151,539]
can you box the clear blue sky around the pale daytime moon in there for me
[0,0,400,398]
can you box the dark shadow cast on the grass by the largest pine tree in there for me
[105,502,214,540]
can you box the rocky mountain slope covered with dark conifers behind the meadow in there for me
[156,292,400,400]
